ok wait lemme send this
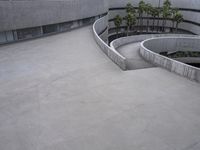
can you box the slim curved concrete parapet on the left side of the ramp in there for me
[93,15,126,70]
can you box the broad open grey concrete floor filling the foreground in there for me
[0,26,200,150]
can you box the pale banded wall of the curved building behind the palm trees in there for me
[109,0,200,34]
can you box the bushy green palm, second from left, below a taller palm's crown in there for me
[124,12,136,36]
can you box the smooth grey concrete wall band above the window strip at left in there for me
[0,0,108,31]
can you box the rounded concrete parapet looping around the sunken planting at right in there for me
[140,37,200,82]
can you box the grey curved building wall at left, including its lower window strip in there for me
[0,0,108,44]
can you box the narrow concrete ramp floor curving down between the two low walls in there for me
[117,42,155,70]
